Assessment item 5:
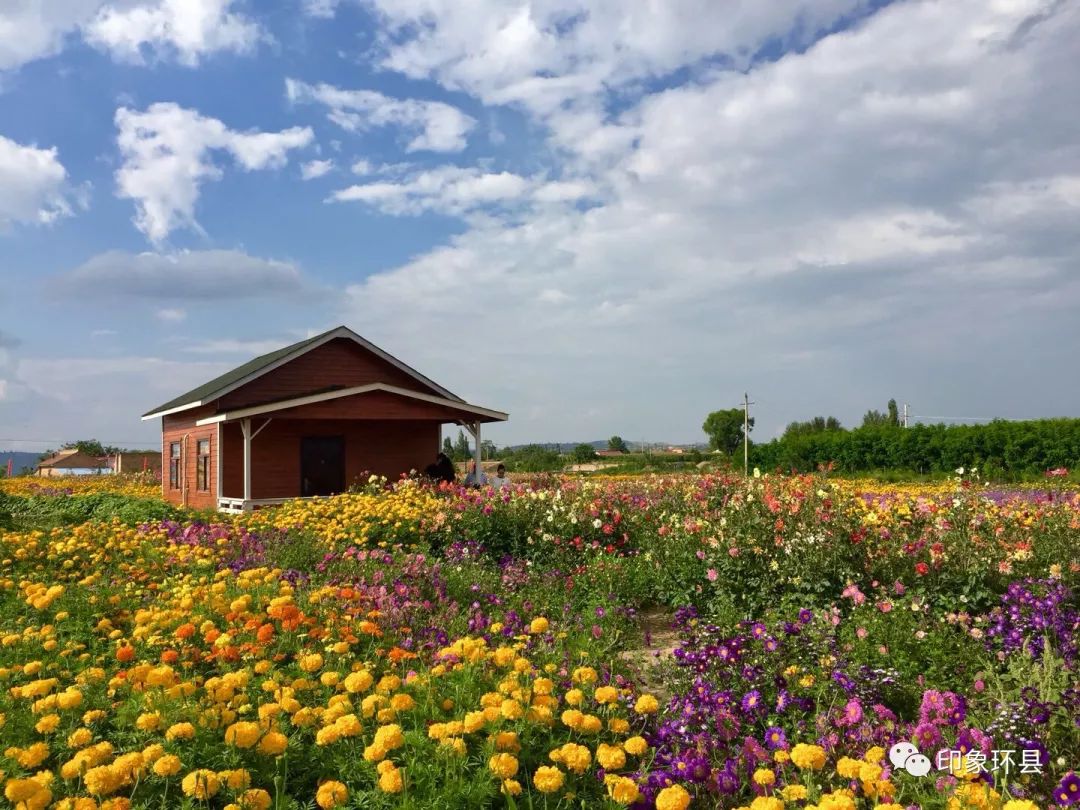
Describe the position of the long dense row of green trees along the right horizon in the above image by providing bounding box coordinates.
[751,419,1080,480]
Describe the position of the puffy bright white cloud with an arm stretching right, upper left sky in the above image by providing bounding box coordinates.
[116,104,312,243]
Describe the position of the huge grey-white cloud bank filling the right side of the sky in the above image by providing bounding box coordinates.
[334,0,1080,441]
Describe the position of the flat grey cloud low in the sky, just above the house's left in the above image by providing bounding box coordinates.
[51,251,318,301]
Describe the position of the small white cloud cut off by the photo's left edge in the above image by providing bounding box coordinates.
[0,135,78,232]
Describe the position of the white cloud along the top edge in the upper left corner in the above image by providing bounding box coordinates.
[0,0,266,70]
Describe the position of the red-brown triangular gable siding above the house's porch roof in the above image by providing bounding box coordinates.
[217,338,442,410]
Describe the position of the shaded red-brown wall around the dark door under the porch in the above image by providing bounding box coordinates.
[219,415,441,498]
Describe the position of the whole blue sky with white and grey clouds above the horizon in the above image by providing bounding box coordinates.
[0,0,1080,449]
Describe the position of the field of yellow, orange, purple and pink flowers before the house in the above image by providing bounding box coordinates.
[0,474,1080,810]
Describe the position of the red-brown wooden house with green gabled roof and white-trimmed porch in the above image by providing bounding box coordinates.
[143,326,508,511]
